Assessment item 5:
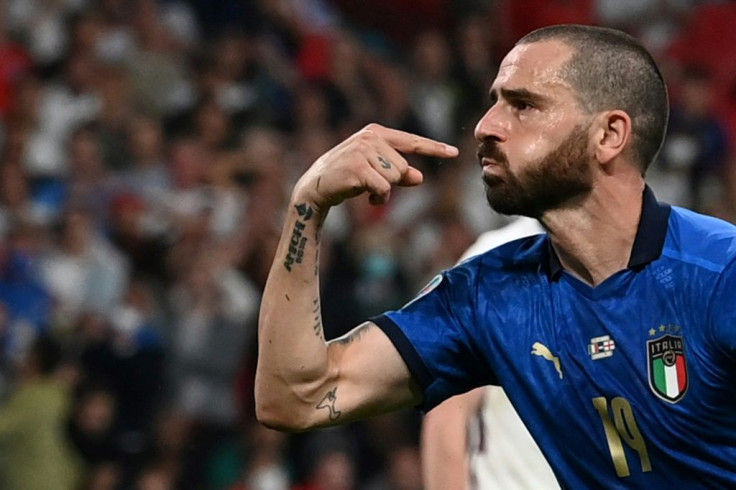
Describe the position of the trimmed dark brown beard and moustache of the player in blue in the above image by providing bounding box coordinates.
[478,126,593,218]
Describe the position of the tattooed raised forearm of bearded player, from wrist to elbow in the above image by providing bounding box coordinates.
[256,192,328,428]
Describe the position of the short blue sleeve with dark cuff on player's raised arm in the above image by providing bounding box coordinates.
[372,262,493,411]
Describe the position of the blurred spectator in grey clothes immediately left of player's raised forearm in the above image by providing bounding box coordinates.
[170,242,257,427]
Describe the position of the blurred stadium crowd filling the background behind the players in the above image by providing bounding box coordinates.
[0,0,736,490]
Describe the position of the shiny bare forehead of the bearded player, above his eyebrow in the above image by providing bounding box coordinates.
[491,41,573,92]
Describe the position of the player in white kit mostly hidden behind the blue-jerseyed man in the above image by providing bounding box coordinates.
[422,217,560,490]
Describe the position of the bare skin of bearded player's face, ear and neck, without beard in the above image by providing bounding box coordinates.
[475,41,644,286]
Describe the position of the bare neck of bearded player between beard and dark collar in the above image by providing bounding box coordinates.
[540,175,644,286]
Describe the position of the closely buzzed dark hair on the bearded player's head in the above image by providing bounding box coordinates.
[517,24,669,174]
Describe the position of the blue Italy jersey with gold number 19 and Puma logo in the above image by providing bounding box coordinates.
[373,189,736,489]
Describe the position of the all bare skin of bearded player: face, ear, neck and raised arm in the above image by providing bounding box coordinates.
[255,41,644,430]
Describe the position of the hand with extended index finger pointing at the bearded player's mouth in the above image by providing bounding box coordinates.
[293,124,458,211]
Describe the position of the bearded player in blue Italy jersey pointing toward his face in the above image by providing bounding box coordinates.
[256,25,736,488]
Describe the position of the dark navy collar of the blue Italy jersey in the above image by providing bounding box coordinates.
[547,186,672,280]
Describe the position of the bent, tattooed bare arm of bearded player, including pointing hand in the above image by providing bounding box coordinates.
[256,125,457,430]
